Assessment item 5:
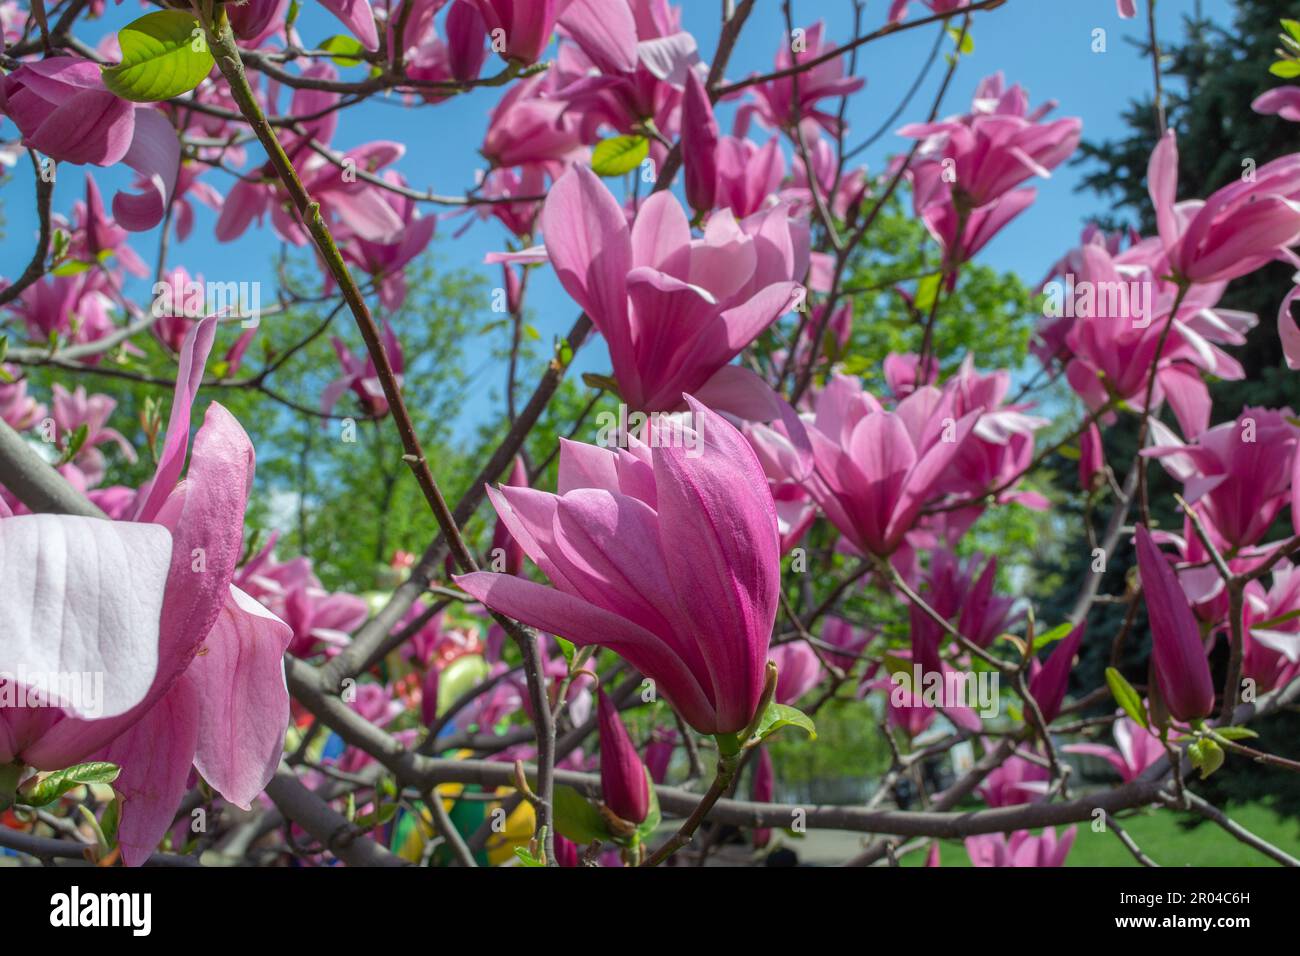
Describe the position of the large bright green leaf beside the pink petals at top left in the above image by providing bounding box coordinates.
[103,10,213,103]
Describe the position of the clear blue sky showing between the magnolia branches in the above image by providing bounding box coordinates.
[0,0,1231,437]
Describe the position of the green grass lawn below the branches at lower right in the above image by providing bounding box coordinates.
[902,804,1300,866]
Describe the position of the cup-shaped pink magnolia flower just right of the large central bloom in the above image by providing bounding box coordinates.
[807,373,979,555]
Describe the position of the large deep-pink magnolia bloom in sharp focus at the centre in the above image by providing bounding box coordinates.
[456,398,780,734]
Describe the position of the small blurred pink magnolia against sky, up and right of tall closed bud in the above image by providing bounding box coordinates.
[742,21,867,135]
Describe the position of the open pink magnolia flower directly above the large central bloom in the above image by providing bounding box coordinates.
[542,166,807,412]
